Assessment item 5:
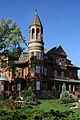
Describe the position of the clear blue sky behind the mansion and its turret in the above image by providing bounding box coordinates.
[0,0,80,75]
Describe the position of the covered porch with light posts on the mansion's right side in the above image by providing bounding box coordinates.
[45,79,80,92]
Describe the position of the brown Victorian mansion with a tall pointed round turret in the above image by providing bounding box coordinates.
[0,12,80,97]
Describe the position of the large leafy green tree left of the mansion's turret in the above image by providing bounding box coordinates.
[0,19,27,68]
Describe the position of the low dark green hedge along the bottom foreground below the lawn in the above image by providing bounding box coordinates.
[0,109,79,120]
